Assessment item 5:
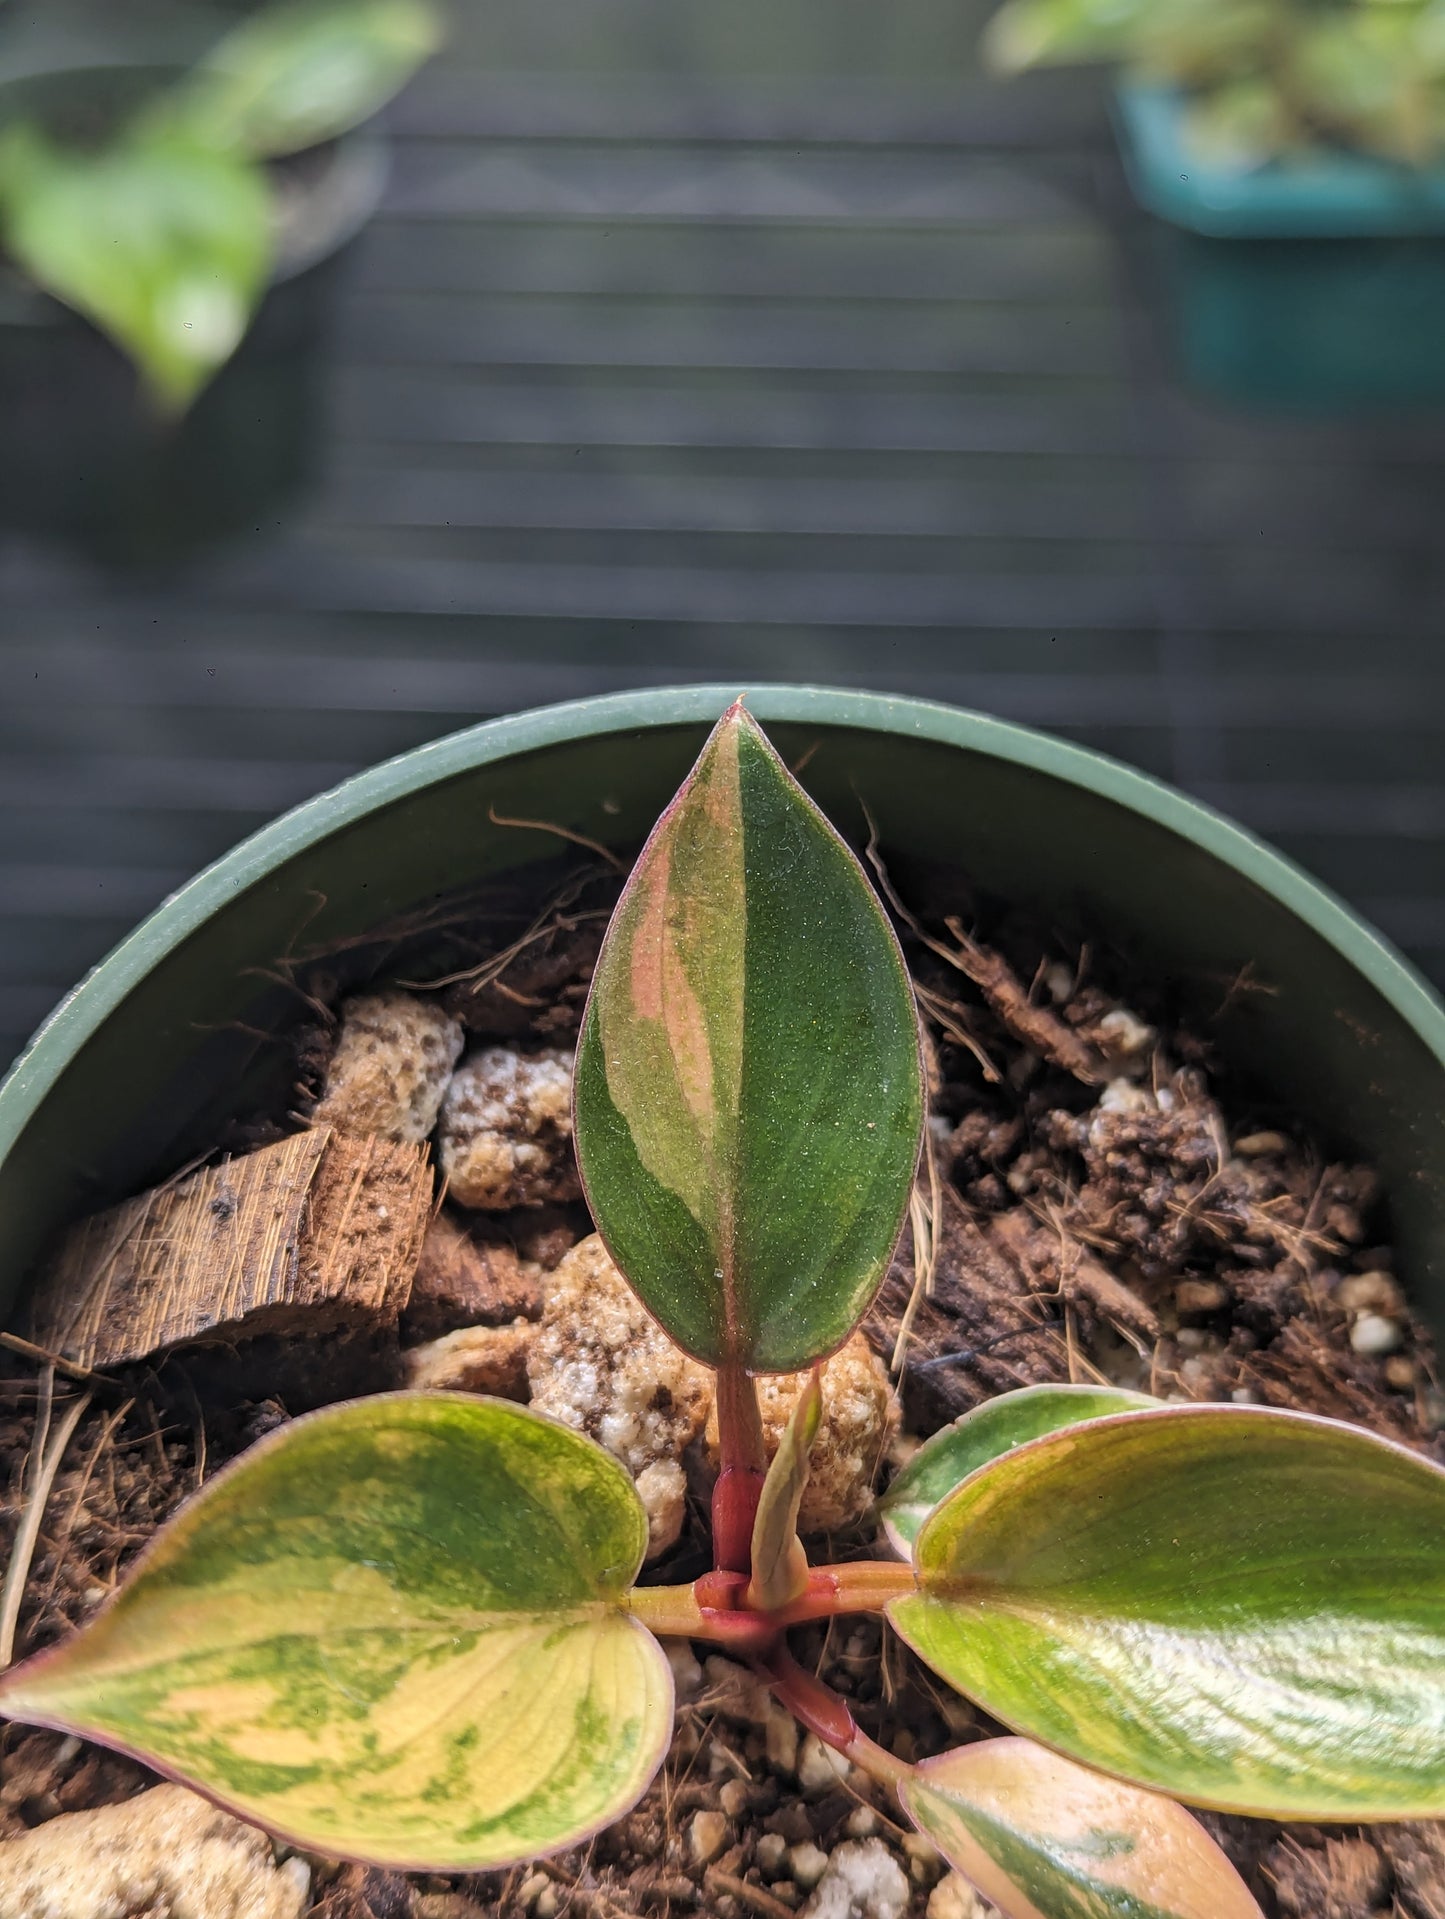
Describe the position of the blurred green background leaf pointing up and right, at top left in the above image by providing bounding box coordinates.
[155,0,441,157]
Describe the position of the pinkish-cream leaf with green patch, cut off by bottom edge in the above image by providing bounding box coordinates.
[898,1739,1261,1919]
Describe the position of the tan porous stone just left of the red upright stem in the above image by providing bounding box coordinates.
[528,1234,712,1558]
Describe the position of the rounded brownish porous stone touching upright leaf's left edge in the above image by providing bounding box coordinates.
[438,1046,581,1213]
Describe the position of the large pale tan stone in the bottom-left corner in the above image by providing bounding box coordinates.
[0,1787,311,1919]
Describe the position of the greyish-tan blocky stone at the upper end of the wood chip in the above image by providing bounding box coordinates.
[311,992,462,1146]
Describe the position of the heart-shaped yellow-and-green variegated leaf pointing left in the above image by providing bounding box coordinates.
[0,1393,672,1871]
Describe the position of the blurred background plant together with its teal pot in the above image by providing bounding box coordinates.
[984,0,1445,409]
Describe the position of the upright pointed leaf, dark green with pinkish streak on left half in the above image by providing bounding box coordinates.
[576,706,923,1372]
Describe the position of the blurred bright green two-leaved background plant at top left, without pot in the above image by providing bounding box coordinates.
[0,0,441,413]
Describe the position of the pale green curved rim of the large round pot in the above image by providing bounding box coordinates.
[0,681,1445,1161]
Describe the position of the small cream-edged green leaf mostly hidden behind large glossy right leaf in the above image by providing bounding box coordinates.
[879,1386,1159,1556]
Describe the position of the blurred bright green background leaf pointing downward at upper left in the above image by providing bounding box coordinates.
[0,125,272,411]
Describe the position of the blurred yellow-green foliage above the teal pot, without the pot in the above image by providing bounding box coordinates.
[984,0,1445,169]
